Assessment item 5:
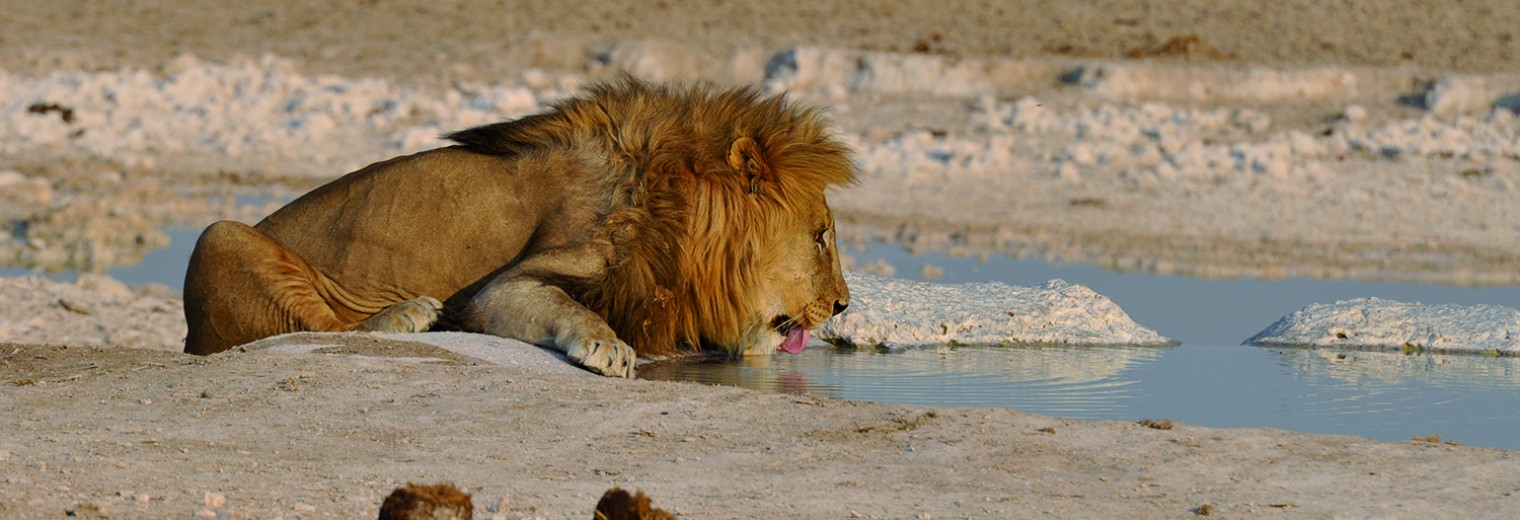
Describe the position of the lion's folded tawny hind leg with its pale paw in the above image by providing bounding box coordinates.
[184,220,442,354]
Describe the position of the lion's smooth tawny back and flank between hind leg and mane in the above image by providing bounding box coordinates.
[255,147,565,298]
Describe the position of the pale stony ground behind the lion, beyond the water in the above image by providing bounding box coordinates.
[0,2,1520,284]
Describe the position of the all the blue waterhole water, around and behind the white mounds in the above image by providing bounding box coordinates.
[0,230,1520,450]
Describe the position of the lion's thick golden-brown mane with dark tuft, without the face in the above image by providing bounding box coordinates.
[447,78,856,357]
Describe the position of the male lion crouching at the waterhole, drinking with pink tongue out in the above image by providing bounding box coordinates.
[184,79,854,377]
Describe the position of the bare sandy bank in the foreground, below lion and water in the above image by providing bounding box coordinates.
[0,341,1520,518]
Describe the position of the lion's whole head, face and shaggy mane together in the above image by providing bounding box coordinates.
[559,81,856,356]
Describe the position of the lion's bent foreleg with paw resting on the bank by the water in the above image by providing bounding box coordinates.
[465,275,637,377]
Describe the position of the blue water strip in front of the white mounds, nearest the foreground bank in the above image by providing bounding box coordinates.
[638,345,1520,450]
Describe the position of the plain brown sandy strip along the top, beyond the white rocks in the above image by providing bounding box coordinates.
[0,0,1520,79]
